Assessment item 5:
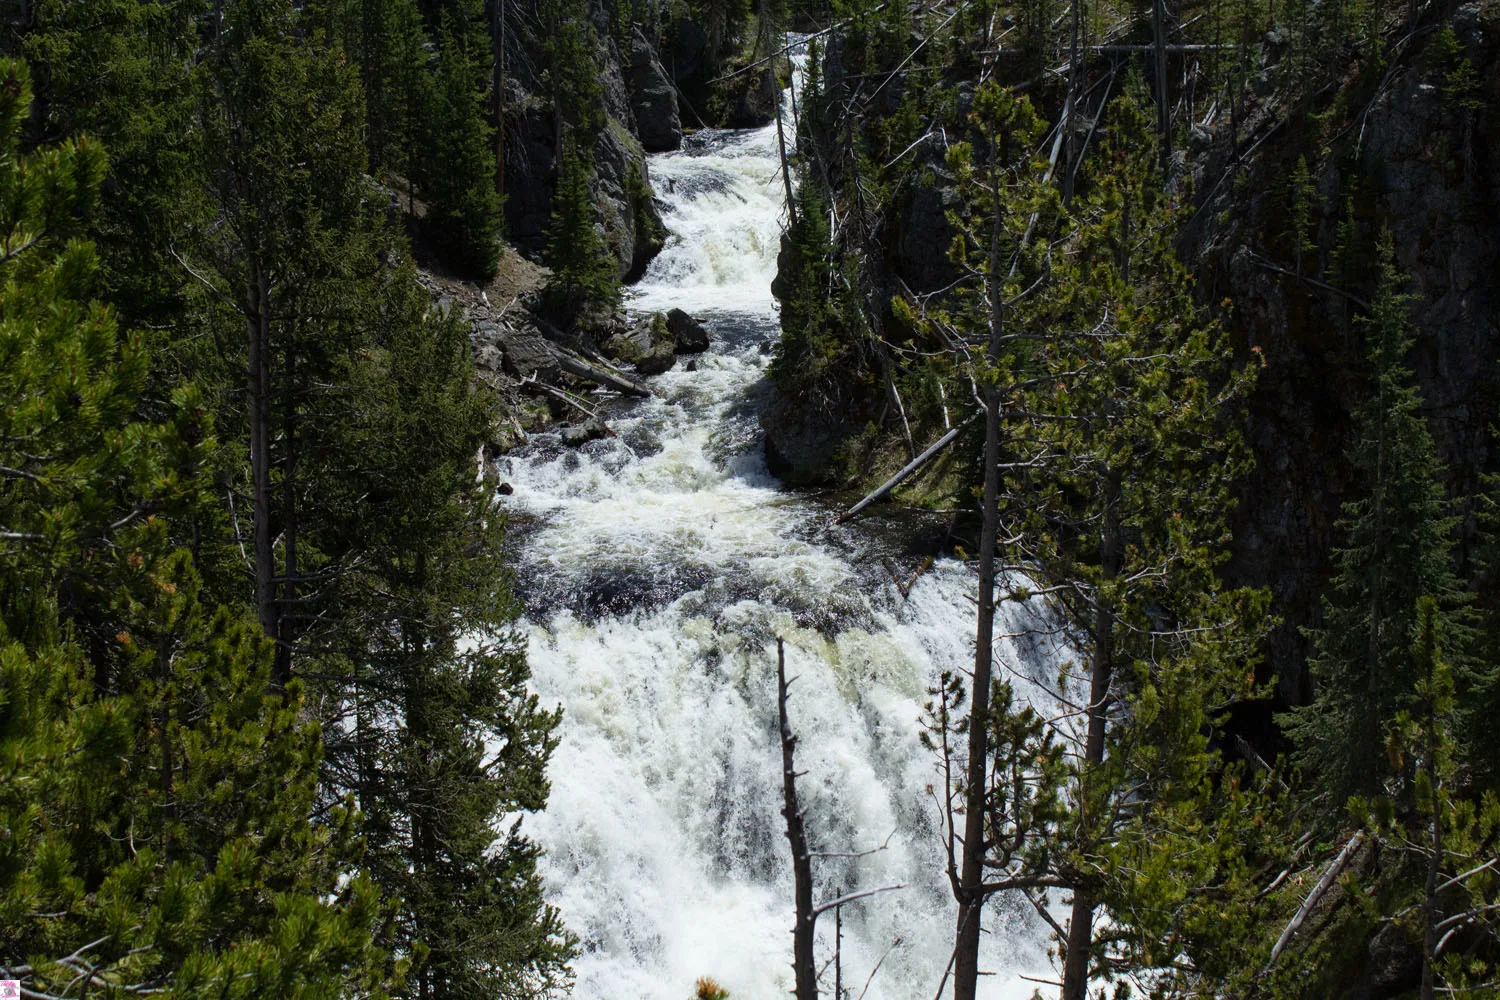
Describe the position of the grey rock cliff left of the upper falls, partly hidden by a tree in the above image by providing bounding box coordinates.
[506,0,683,279]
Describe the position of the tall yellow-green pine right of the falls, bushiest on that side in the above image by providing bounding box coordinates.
[1038,99,1268,999]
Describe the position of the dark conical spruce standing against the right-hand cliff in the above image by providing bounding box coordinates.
[1287,234,1460,801]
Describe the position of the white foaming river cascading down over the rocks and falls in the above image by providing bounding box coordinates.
[501,64,1049,1000]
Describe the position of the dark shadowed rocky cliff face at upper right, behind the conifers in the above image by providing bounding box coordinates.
[1182,3,1500,702]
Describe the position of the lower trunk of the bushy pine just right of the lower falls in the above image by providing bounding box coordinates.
[1061,475,1122,1000]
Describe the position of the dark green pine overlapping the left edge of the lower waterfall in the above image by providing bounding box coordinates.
[320,273,572,1000]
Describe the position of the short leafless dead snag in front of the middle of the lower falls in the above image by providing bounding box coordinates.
[776,639,906,1000]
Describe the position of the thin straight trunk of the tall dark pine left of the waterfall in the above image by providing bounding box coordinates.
[245,264,278,665]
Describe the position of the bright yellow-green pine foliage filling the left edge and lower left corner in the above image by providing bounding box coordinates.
[0,61,399,1000]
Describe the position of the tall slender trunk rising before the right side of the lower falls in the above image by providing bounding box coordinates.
[953,142,1005,1000]
